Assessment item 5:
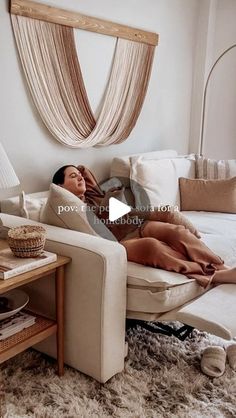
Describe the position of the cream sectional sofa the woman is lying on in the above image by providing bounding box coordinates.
[1,151,236,382]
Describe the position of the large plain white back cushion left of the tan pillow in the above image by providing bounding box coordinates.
[130,155,195,208]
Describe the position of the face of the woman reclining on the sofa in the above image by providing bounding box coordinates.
[61,166,86,197]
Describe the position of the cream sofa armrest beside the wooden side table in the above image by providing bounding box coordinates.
[1,214,127,382]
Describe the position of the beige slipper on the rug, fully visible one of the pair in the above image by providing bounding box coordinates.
[201,346,226,377]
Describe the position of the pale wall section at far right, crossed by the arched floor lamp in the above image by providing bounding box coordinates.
[204,0,236,158]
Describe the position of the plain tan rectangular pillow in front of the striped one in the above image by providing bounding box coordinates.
[179,177,236,213]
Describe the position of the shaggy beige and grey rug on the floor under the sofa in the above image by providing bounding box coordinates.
[0,327,236,418]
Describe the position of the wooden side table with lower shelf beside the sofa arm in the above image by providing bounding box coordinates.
[0,240,71,376]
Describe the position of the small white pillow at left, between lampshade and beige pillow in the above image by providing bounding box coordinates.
[19,191,47,222]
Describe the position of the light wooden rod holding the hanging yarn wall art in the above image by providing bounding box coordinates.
[11,0,158,46]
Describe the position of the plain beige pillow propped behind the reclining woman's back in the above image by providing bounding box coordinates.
[40,184,97,235]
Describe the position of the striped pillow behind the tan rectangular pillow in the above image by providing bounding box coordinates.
[196,156,236,180]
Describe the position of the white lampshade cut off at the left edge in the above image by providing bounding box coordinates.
[0,143,20,189]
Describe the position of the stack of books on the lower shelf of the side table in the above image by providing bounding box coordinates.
[0,312,36,341]
